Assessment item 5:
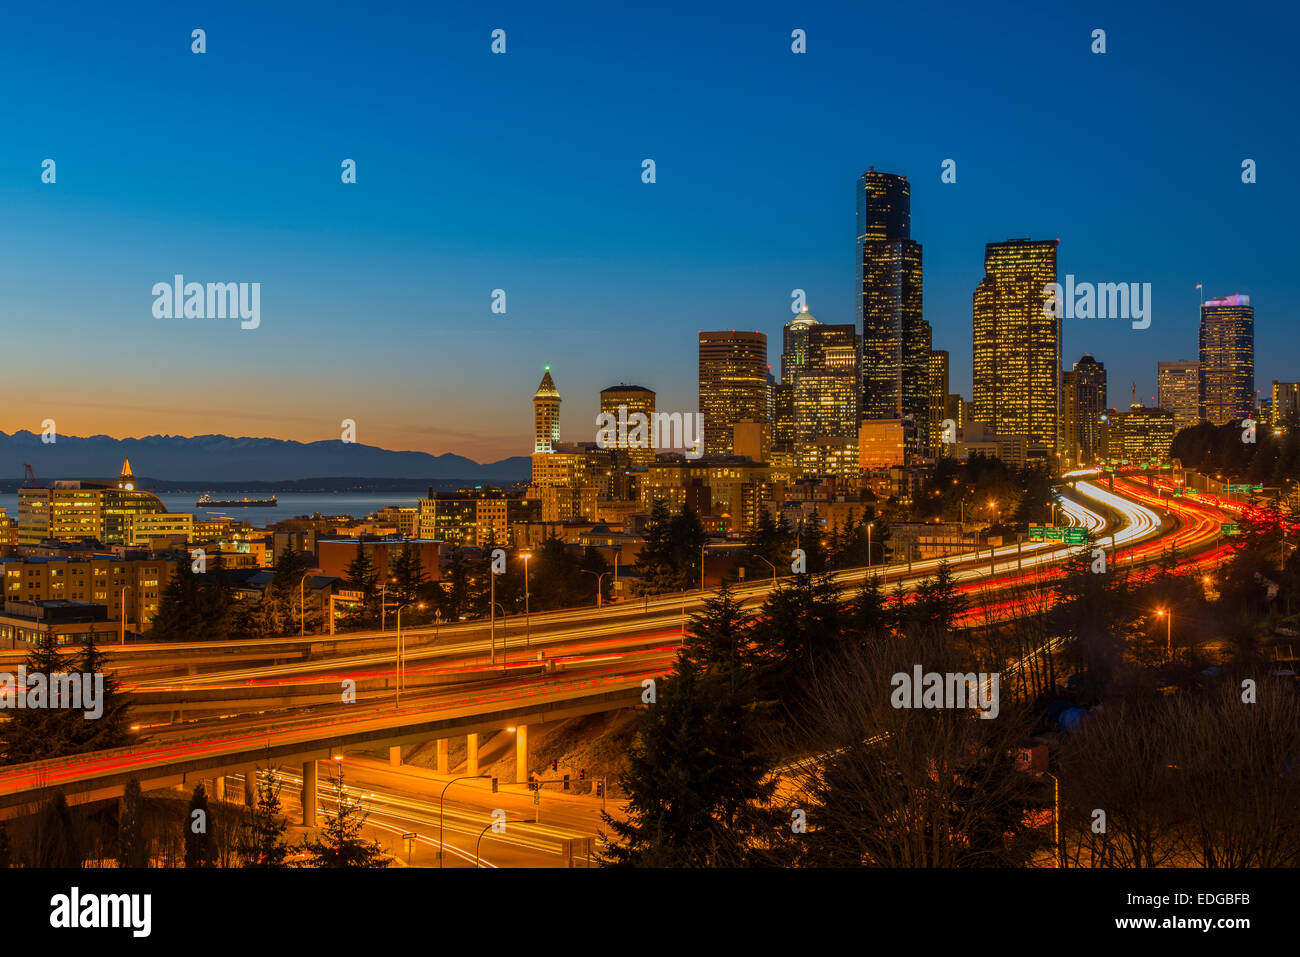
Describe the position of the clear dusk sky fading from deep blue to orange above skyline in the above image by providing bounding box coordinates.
[0,1,1300,462]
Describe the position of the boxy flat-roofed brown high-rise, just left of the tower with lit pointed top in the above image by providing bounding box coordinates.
[699,330,767,455]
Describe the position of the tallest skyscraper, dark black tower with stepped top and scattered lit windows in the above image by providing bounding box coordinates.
[857,168,930,456]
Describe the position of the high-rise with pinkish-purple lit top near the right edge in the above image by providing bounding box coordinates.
[1200,294,1255,425]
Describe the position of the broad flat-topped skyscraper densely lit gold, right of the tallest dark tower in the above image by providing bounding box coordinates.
[972,239,1061,459]
